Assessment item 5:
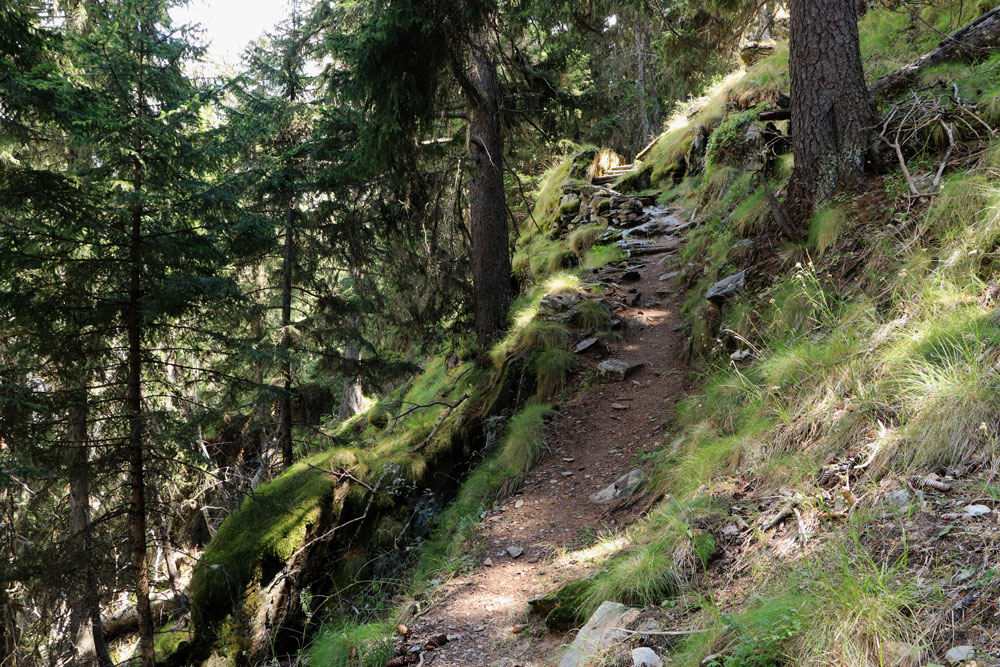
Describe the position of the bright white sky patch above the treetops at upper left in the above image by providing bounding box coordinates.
[170,0,289,66]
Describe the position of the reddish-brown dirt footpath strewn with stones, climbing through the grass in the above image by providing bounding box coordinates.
[407,211,690,667]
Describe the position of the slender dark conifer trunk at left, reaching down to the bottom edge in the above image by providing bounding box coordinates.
[125,70,156,667]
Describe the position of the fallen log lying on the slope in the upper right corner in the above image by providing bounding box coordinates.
[872,7,1000,99]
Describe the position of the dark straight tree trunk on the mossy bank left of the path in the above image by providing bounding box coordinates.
[469,30,510,364]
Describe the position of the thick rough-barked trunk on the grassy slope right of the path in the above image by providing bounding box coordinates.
[786,0,878,222]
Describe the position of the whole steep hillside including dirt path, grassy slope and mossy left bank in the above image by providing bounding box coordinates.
[175,3,1000,667]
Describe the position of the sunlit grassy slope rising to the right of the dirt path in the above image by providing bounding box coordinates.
[553,3,1000,667]
